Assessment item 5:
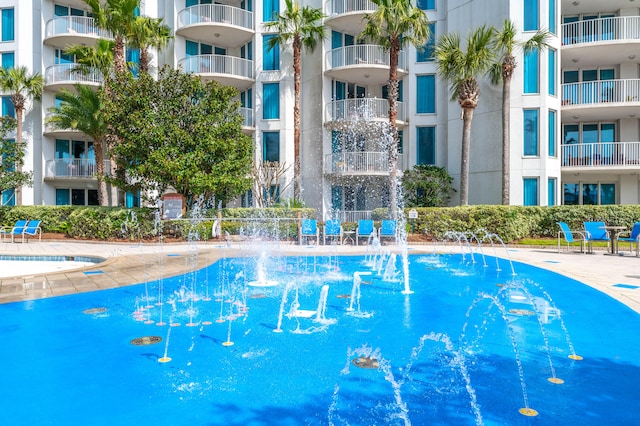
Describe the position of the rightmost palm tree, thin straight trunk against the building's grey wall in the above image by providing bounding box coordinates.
[490,19,550,205]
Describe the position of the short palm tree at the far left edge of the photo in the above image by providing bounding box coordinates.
[0,66,44,205]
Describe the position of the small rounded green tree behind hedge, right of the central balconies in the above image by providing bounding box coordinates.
[402,164,455,207]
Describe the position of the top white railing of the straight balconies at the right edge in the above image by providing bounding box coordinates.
[562,16,640,45]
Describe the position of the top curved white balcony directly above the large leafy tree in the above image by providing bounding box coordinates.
[176,4,255,47]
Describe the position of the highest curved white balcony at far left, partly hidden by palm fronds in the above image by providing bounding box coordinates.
[44,16,113,49]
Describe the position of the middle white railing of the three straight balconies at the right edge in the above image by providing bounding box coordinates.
[562,79,640,105]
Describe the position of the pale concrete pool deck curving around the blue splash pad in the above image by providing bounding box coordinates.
[0,240,640,313]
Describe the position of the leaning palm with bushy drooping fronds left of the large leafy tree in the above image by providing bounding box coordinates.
[46,84,109,206]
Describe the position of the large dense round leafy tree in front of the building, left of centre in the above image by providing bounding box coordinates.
[103,67,252,206]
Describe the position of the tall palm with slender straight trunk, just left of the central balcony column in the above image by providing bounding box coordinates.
[264,0,325,200]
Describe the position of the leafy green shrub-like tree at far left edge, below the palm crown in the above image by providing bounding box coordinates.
[0,115,33,204]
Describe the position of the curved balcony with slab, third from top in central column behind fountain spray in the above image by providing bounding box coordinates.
[325,98,407,130]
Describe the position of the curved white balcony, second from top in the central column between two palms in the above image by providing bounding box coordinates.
[325,44,407,85]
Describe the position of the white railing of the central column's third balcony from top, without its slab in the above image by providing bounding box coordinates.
[327,98,407,121]
